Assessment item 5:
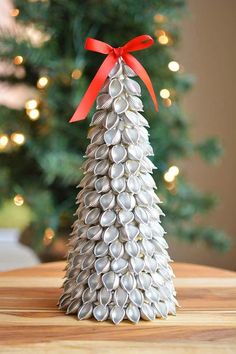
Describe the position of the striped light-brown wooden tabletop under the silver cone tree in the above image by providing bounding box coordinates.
[0,262,236,354]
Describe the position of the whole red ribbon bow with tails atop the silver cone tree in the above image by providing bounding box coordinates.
[70,34,158,123]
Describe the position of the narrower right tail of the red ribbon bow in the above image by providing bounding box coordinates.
[123,53,158,111]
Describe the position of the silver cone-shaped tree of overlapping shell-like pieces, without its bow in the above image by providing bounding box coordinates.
[59,54,177,324]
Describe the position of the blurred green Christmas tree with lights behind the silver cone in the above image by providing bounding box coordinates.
[0,0,228,252]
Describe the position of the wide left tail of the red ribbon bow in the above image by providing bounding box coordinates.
[70,53,117,123]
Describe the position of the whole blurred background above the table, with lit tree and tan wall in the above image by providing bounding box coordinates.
[0,0,236,270]
